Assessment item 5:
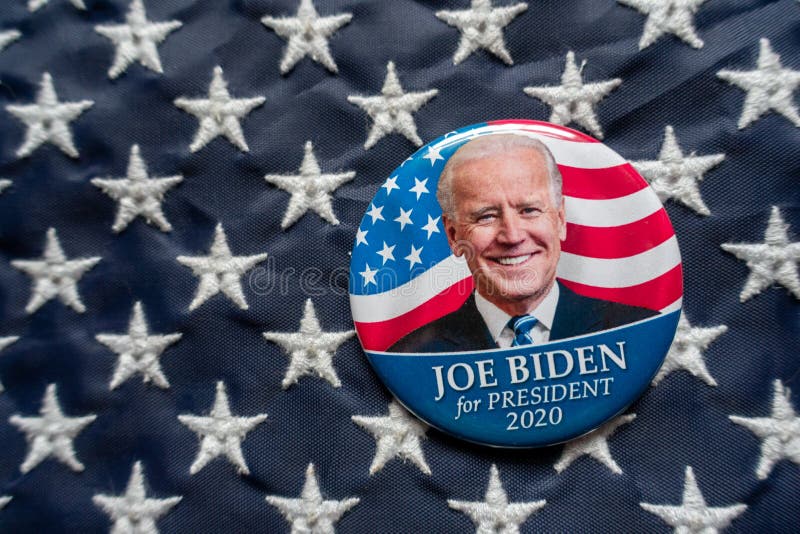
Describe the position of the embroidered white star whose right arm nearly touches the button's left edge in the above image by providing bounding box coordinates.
[264,299,355,389]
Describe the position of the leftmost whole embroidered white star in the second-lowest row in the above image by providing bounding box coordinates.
[8,384,97,473]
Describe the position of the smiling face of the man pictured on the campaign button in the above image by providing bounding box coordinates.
[442,147,567,315]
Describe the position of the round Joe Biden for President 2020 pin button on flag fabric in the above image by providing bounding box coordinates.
[350,120,683,447]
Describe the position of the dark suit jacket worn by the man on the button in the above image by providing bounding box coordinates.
[387,284,658,352]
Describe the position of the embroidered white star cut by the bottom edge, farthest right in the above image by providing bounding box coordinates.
[639,466,747,534]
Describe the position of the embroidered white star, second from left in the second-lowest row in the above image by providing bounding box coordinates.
[178,381,267,475]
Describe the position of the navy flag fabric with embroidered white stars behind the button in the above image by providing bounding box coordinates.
[0,0,800,533]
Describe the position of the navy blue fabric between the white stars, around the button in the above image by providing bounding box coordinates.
[0,0,800,532]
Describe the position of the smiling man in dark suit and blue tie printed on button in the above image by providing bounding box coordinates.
[388,134,657,352]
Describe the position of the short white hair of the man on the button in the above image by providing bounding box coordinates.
[436,134,562,218]
